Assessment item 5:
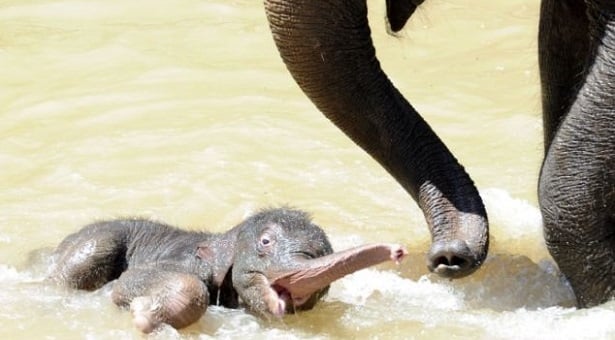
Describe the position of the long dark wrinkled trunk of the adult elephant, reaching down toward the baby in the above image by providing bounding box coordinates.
[265,0,489,277]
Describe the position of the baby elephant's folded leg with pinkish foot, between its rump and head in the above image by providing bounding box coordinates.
[111,267,209,333]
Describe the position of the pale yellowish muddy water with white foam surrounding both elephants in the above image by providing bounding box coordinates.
[0,0,615,339]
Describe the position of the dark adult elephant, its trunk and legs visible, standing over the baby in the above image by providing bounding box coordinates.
[265,0,615,306]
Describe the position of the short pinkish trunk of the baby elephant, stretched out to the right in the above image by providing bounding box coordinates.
[272,244,408,297]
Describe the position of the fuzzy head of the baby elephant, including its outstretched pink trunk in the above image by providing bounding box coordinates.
[224,209,407,317]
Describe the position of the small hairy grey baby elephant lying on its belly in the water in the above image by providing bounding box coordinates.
[49,208,407,333]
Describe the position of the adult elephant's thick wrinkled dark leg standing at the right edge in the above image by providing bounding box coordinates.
[539,0,615,307]
